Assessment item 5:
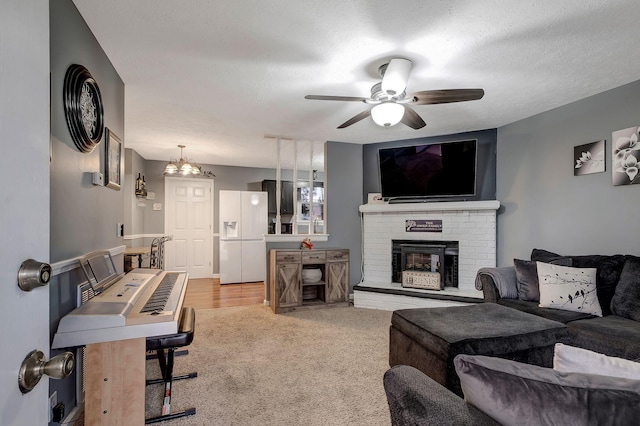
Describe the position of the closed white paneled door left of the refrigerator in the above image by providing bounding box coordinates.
[165,178,213,278]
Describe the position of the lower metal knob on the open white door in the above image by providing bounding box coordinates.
[18,350,75,393]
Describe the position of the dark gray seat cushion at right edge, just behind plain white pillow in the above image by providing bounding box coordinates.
[567,315,640,361]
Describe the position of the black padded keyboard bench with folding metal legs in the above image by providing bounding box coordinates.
[145,306,198,424]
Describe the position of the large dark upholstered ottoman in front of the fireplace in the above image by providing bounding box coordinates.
[389,303,567,396]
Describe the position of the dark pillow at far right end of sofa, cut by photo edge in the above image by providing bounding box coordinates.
[611,256,640,321]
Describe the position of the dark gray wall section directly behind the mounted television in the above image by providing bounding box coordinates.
[362,129,496,203]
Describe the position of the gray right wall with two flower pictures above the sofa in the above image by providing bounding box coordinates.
[497,81,640,266]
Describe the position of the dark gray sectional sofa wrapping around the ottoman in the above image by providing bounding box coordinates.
[384,249,640,426]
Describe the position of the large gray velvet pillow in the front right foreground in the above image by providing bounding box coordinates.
[453,355,640,425]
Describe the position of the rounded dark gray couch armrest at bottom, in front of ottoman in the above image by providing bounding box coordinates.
[384,365,498,426]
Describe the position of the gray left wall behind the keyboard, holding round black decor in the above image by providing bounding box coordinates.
[49,0,126,420]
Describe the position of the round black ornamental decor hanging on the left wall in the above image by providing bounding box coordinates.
[63,64,104,152]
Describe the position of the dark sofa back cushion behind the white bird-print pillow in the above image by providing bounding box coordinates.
[531,248,625,315]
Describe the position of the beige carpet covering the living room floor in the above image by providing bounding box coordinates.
[146,305,391,426]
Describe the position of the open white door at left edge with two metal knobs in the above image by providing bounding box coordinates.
[0,0,49,425]
